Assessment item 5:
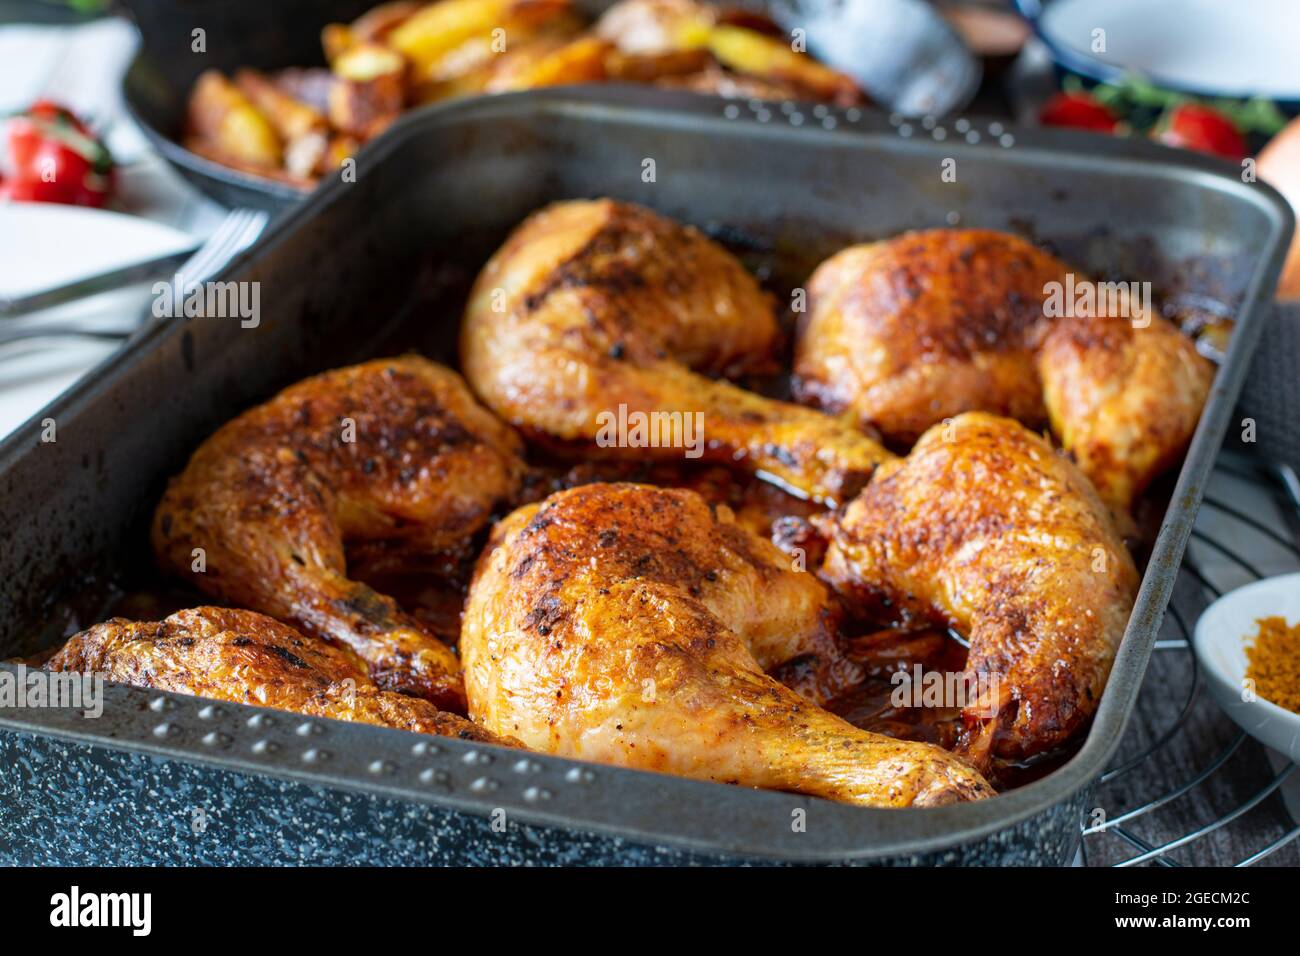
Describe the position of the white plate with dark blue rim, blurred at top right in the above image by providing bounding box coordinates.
[1040,0,1300,100]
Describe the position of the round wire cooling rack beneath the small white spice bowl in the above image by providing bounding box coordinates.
[1079,451,1300,866]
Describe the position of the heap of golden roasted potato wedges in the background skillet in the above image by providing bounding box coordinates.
[175,0,863,183]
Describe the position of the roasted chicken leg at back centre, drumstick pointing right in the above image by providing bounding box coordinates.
[460,199,891,501]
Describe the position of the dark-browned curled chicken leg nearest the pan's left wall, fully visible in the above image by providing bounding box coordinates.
[153,356,524,711]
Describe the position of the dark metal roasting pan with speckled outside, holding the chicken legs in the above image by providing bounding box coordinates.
[0,87,1292,864]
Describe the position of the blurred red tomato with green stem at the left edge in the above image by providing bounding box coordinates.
[4,100,113,207]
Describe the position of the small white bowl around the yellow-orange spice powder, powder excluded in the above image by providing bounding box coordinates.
[1192,574,1300,763]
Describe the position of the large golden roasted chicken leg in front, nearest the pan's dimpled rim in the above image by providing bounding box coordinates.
[460,484,992,806]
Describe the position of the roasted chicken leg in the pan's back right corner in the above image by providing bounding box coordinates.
[794,229,1213,514]
